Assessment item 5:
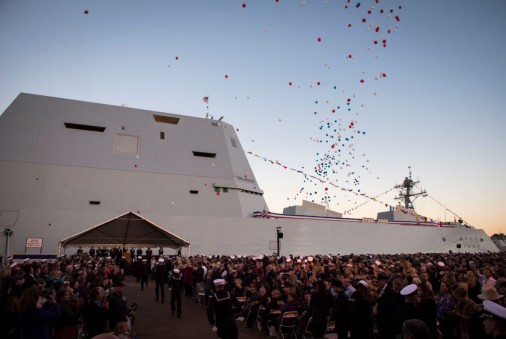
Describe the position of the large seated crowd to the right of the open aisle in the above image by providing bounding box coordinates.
[191,253,506,338]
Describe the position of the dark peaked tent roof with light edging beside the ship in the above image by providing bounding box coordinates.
[60,212,190,249]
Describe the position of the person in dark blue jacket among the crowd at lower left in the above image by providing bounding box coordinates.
[19,286,60,339]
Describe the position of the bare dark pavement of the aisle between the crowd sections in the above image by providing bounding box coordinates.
[123,276,267,339]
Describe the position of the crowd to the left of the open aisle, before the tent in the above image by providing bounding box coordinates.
[0,253,131,339]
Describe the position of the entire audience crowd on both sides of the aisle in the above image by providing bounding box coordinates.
[0,248,506,339]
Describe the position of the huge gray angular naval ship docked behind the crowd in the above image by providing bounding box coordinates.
[0,93,498,255]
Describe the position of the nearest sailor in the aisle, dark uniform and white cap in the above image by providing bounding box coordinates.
[207,279,238,339]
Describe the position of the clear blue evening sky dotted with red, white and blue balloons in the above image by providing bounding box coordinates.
[0,0,506,235]
